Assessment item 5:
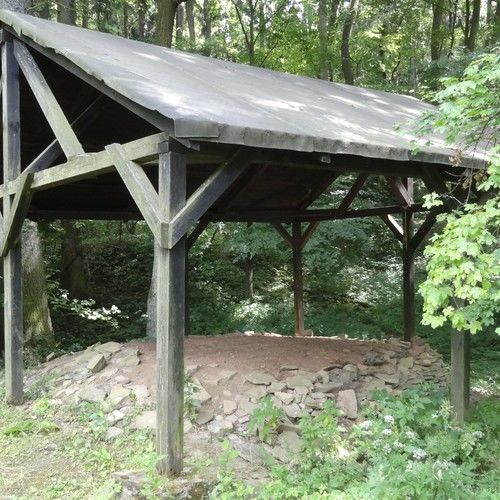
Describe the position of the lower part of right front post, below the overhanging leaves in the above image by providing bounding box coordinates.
[450,332,470,424]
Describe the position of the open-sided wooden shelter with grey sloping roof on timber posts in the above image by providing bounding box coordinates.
[0,11,476,473]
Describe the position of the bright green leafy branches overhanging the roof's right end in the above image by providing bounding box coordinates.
[412,49,500,334]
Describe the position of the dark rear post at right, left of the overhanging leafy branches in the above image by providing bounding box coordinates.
[403,178,415,342]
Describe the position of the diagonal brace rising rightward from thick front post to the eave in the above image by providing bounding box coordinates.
[167,148,255,248]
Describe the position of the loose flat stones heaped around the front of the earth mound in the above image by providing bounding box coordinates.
[37,338,446,460]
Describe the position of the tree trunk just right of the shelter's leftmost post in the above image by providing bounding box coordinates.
[22,220,54,346]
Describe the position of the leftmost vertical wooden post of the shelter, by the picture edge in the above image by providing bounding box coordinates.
[2,37,23,404]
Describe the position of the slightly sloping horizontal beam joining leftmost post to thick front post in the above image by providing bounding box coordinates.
[0,132,168,197]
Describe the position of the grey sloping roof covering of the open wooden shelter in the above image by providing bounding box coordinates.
[0,10,480,164]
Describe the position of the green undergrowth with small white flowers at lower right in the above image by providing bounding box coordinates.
[215,385,500,500]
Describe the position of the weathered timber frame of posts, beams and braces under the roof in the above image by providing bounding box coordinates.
[0,30,468,473]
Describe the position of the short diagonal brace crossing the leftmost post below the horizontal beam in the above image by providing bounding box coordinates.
[2,171,34,257]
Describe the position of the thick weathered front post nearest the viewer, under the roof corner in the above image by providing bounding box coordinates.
[155,143,186,475]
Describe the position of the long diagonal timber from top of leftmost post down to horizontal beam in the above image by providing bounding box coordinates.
[14,40,85,158]
